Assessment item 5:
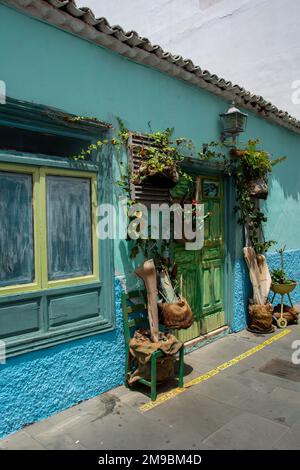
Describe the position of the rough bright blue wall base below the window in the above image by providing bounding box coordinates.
[0,279,125,438]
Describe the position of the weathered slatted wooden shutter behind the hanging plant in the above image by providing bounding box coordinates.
[128,134,170,207]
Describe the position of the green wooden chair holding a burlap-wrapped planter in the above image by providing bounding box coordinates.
[122,291,184,401]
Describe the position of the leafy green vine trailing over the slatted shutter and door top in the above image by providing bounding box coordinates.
[73,118,286,256]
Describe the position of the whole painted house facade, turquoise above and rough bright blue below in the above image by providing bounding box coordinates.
[0,5,300,436]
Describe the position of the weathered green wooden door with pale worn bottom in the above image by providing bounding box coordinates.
[173,176,225,341]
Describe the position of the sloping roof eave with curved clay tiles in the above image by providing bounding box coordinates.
[1,0,300,134]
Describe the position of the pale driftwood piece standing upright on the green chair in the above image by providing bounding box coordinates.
[135,259,159,343]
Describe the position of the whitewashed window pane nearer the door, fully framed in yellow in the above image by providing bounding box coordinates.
[47,176,93,280]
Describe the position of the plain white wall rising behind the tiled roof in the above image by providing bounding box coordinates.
[77,0,300,119]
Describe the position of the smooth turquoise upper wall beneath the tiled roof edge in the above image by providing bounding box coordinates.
[0,5,300,260]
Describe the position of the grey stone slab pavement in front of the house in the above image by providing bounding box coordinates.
[0,325,300,450]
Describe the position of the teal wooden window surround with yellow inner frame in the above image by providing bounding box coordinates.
[0,97,116,357]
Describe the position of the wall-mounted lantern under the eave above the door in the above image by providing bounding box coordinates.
[220,101,248,147]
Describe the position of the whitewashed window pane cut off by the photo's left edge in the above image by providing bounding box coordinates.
[0,171,34,287]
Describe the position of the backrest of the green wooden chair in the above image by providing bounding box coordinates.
[122,290,149,347]
